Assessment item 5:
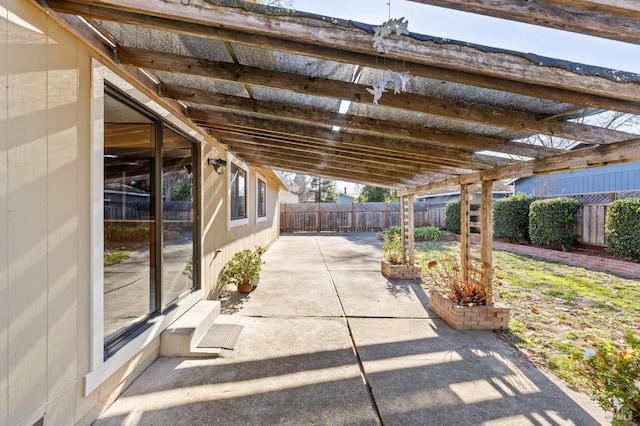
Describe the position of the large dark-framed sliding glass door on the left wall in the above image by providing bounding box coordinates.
[103,86,198,359]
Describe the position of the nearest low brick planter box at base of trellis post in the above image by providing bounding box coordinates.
[429,290,511,330]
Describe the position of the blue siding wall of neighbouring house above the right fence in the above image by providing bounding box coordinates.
[515,163,640,196]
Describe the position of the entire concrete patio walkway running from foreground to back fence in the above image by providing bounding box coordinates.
[96,234,608,426]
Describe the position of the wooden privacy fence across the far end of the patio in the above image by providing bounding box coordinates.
[280,202,444,232]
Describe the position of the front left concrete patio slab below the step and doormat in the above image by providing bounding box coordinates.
[95,318,377,426]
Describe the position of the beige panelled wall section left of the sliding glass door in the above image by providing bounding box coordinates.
[0,0,90,425]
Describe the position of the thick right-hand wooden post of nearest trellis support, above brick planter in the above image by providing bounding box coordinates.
[480,180,493,305]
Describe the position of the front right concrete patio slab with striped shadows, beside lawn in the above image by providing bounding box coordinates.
[349,318,605,426]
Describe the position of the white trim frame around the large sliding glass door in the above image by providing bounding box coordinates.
[83,59,204,397]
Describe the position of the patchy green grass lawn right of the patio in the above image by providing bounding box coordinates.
[416,241,640,391]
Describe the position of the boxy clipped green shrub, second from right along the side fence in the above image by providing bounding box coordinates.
[529,197,580,250]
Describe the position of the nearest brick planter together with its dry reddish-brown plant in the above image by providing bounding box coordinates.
[427,257,510,330]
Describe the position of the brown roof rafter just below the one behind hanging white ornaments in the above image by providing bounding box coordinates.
[160,84,563,158]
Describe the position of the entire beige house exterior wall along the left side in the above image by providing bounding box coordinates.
[0,0,279,426]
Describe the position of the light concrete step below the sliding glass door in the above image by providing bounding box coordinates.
[160,300,221,357]
